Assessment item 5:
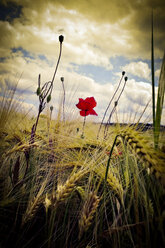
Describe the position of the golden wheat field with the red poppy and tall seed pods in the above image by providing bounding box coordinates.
[0,34,165,248]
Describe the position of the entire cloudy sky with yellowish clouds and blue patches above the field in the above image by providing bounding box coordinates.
[0,0,165,124]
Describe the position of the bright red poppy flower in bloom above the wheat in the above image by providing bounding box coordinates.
[76,97,97,116]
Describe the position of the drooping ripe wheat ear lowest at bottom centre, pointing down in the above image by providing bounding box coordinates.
[79,192,100,239]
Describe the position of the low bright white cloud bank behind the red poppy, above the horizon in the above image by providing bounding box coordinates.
[1,46,164,123]
